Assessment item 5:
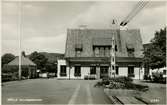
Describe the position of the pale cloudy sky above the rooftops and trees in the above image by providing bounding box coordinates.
[1,1,167,55]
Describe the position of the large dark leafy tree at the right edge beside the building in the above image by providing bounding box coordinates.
[144,28,166,69]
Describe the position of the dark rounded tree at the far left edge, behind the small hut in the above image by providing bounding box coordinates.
[1,53,15,67]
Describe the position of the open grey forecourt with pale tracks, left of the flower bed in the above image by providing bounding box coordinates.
[2,78,111,104]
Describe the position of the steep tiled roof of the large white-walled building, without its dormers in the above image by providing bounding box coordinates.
[65,29,143,58]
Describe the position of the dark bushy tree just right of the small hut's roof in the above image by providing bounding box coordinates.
[29,51,48,70]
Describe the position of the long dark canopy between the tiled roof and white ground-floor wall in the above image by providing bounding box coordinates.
[66,57,142,67]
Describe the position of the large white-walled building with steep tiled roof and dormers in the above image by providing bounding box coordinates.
[57,29,144,79]
